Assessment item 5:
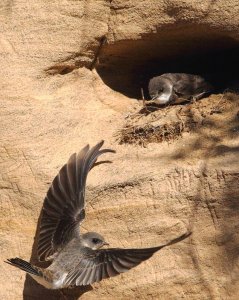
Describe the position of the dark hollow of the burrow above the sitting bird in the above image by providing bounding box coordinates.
[96,24,239,99]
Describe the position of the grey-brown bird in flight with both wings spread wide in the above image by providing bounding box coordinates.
[6,141,190,289]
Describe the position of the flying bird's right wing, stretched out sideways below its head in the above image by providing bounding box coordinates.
[64,233,191,286]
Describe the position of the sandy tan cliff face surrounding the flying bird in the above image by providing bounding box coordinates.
[0,0,239,300]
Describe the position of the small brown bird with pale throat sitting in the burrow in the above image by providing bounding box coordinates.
[148,73,214,104]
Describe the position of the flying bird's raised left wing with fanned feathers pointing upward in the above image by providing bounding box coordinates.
[38,141,115,261]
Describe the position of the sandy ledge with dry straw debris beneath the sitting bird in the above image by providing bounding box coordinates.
[116,93,239,146]
